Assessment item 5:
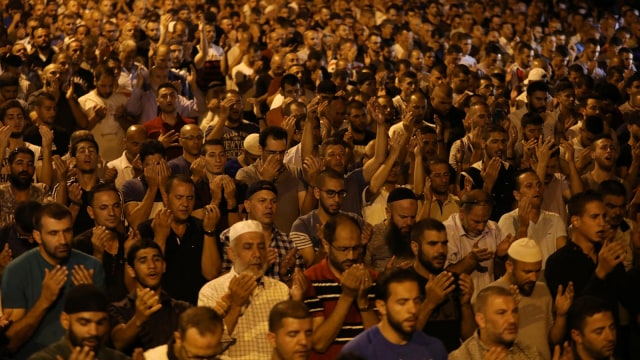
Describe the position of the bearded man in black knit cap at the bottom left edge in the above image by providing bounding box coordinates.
[29,284,129,360]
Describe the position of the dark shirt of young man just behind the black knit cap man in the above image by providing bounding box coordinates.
[109,290,193,350]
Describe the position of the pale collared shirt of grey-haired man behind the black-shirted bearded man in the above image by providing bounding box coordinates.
[444,213,502,291]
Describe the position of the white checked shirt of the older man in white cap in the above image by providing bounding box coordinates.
[198,268,289,360]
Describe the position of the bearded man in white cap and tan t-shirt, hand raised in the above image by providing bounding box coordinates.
[490,238,574,360]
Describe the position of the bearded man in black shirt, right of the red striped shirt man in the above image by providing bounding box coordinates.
[411,218,476,351]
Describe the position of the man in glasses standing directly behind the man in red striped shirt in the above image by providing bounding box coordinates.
[289,169,364,267]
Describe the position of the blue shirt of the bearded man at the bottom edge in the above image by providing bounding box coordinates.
[340,325,447,360]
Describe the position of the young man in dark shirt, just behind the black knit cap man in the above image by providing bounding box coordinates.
[109,239,192,353]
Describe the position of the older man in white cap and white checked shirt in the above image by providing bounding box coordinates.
[198,220,289,360]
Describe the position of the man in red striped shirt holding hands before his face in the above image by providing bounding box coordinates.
[304,214,378,359]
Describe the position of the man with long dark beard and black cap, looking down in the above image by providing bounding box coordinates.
[364,187,418,272]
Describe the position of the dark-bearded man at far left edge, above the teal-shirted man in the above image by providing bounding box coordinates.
[0,147,47,226]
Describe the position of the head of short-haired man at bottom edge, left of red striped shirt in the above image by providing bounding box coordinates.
[267,300,313,360]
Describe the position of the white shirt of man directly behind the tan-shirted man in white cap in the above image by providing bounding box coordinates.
[498,209,567,269]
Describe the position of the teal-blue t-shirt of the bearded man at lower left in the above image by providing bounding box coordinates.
[2,248,105,359]
